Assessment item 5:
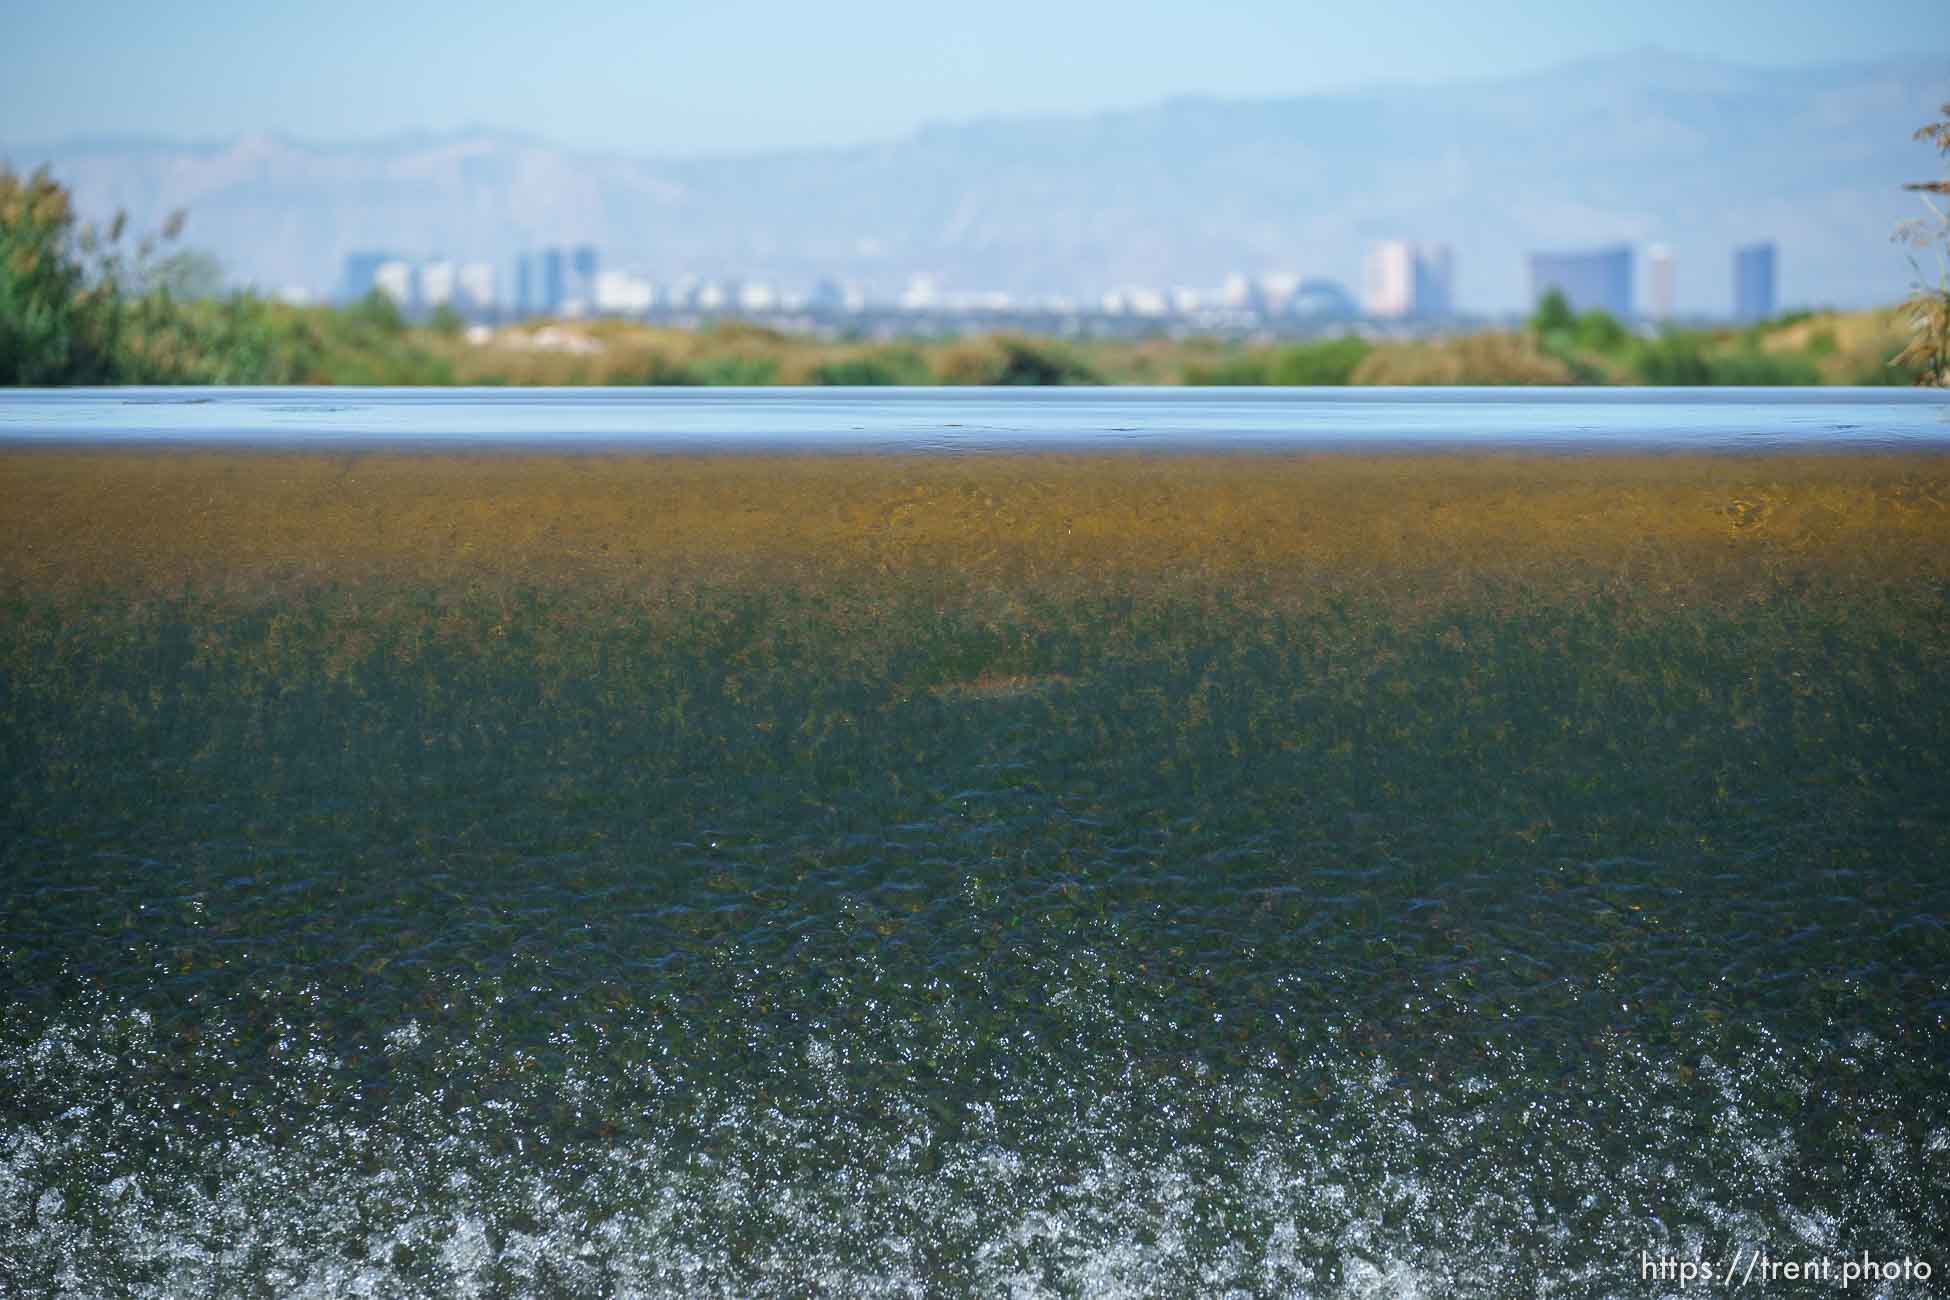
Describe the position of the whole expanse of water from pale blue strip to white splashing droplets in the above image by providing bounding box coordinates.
[0,390,1950,1296]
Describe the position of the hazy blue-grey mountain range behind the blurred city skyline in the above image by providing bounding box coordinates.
[0,51,1950,314]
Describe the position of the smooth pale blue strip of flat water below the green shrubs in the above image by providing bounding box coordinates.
[0,388,1950,452]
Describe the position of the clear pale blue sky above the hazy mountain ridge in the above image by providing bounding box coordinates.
[15,0,1950,154]
